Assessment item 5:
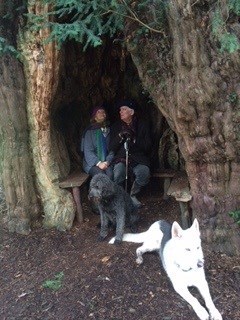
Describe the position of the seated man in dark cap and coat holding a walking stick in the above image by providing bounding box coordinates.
[109,100,151,206]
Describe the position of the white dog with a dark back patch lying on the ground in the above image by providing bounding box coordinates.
[109,219,222,320]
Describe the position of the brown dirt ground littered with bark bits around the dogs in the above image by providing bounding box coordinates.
[0,182,240,320]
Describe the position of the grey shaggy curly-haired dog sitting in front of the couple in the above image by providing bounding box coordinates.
[88,173,138,244]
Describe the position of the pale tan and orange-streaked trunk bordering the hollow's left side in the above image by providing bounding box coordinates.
[21,2,76,230]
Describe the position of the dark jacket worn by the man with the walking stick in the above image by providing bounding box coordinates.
[109,119,152,167]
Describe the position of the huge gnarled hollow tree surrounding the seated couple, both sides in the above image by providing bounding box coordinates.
[0,0,240,254]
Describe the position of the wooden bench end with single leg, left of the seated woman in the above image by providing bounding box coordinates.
[59,171,89,223]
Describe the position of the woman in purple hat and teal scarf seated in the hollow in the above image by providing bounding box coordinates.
[81,106,113,179]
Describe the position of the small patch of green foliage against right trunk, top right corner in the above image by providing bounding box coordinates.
[212,0,240,53]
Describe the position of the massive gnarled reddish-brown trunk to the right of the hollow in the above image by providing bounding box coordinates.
[129,0,240,254]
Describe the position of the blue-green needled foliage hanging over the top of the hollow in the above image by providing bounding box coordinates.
[28,0,126,49]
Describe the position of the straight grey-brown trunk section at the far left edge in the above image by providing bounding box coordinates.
[0,3,40,234]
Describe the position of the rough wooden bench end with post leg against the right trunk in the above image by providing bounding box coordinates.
[167,172,192,229]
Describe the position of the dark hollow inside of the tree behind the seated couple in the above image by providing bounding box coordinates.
[52,39,181,170]
